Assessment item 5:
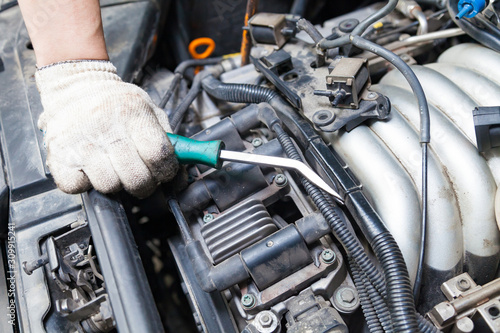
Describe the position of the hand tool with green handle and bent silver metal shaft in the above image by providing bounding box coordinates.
[167,133,344,204]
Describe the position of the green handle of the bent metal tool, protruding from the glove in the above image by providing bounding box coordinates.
[167,133,224,169]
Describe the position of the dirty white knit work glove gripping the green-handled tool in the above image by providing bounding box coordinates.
[35,60,178,197]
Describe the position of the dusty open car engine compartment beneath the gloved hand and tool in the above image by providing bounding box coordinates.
[0,0,500,333]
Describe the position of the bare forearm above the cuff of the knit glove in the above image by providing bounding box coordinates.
[19,0,108,66]
